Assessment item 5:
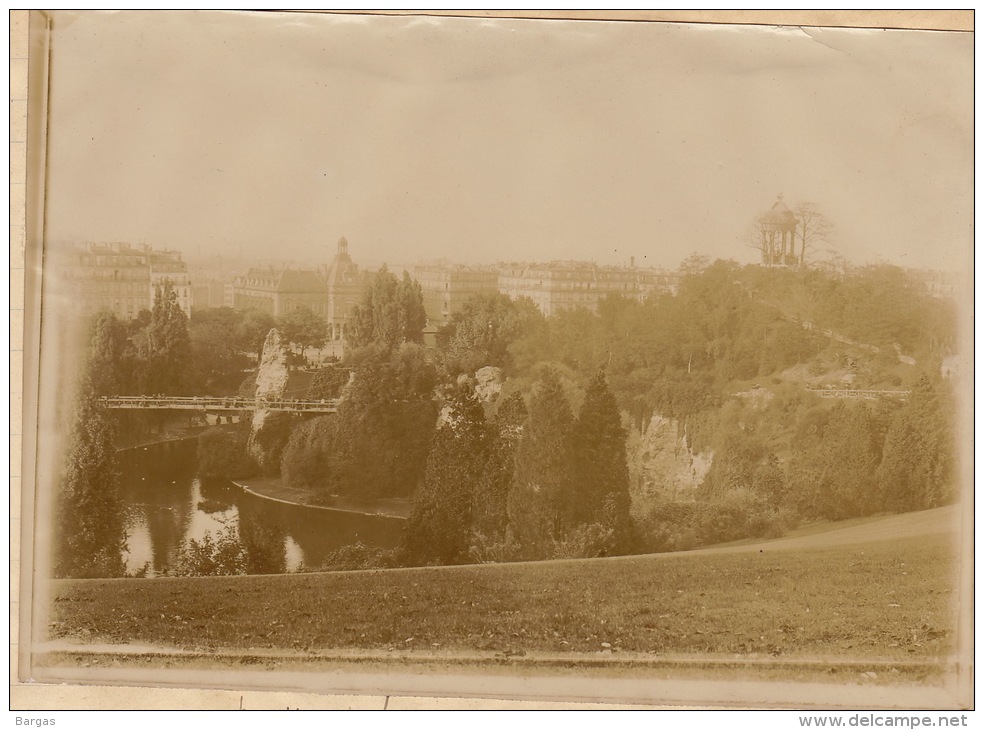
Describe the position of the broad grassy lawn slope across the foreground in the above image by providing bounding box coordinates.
[51,535,956,660]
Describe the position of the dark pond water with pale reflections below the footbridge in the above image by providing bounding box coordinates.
[118,439,404,577]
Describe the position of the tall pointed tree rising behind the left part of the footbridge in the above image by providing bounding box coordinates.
[138,279,191,395]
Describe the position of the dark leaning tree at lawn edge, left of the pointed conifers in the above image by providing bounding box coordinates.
[406,383,489,565]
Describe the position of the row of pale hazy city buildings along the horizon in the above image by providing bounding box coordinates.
[55,237,955,352]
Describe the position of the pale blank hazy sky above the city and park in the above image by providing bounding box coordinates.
[40,12,973,269]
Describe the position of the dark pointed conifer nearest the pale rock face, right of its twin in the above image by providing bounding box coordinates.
[573,370,631,550]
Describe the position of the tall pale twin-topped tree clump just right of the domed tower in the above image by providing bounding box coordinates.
[348,266,427,348]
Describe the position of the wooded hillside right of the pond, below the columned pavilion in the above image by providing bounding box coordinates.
[404,257,956,559]
